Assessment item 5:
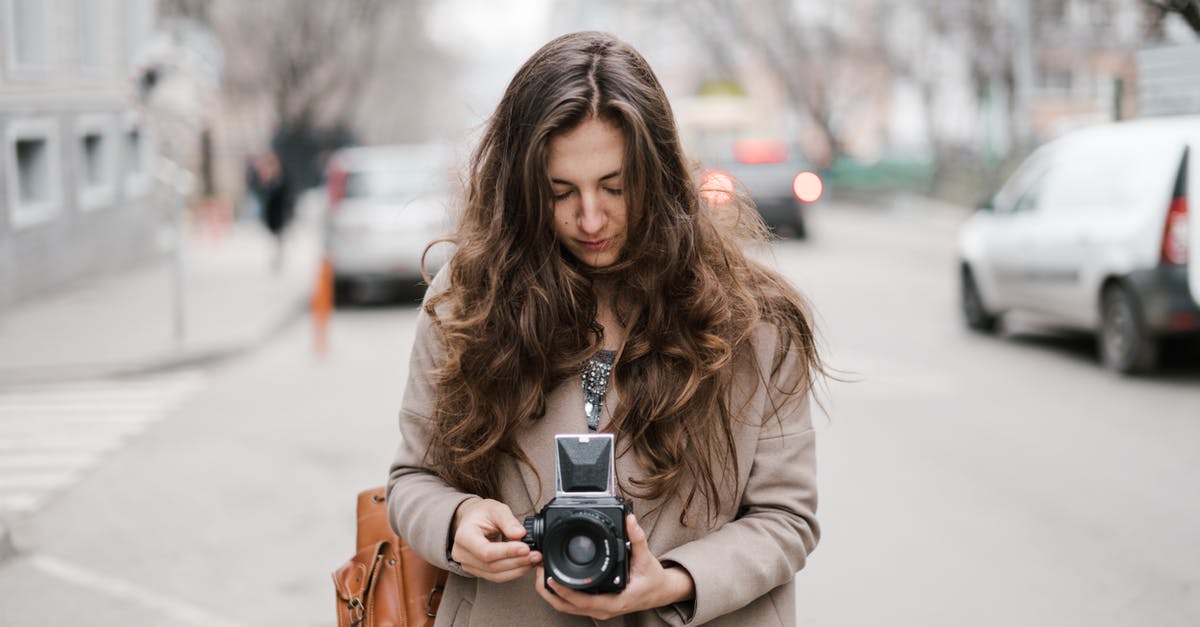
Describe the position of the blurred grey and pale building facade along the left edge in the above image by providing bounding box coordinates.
[0,0,162,314]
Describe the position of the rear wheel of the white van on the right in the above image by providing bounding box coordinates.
[1099,285,1158,374]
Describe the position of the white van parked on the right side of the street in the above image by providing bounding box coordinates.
[959,117,1200,372]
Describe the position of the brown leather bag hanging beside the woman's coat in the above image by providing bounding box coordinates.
[334,488,446,627]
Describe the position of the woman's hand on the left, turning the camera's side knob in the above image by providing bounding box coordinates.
[450,497,541,584]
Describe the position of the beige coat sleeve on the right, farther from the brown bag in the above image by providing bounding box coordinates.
[658,329,820,626]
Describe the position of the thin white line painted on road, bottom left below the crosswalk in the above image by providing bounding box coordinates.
[29,555,247,627]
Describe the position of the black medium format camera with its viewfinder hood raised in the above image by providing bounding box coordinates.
[524,434,632,595]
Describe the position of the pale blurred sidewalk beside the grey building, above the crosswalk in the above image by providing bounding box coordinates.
[0,213,320,390]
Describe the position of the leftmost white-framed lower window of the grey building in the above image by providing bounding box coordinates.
[4,119,61,228]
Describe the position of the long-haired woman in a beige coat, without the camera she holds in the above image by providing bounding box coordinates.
[388,32,823,626]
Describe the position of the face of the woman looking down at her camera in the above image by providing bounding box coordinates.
[547,118,625,268]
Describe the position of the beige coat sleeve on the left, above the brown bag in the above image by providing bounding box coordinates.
[388,273,470,574]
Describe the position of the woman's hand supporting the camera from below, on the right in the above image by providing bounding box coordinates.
[535,514,695,621]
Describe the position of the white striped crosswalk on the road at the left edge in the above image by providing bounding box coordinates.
[0,371,205,514]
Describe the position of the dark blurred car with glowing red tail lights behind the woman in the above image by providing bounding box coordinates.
[707,139,824,239]
